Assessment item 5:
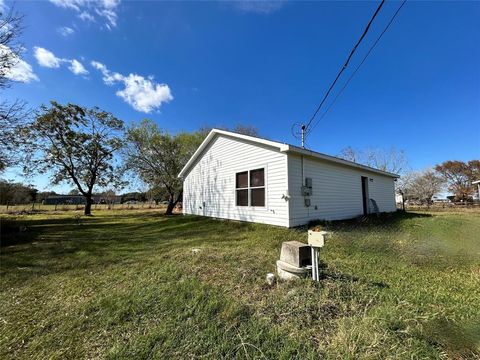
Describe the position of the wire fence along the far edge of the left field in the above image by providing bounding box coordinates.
[0,202,167,214]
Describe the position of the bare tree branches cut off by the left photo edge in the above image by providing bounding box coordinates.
[0,8,29,172]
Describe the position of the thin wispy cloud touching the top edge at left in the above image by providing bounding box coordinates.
[49,0,120,29]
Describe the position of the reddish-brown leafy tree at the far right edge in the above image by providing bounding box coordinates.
[435,160,480,201]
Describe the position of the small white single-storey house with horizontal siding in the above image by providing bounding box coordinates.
[179,129,398,227]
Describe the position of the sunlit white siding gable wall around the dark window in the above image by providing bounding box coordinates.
[183,135,288,226]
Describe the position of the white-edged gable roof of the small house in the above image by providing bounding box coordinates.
[178,129,400,178]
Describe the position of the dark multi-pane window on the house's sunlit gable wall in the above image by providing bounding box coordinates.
[235,169,265,206]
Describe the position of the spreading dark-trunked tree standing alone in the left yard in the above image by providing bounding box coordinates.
[25,101,124,215]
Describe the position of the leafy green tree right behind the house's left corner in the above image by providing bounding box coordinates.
[124,120,203,215]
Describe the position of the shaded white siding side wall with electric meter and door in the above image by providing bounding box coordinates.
[288,155,396,226]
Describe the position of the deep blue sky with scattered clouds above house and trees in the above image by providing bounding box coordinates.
[0,0,480,194]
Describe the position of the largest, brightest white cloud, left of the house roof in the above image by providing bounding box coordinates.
[91,61,173,113]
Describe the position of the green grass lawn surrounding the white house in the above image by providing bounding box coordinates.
[0,210,480,359]
